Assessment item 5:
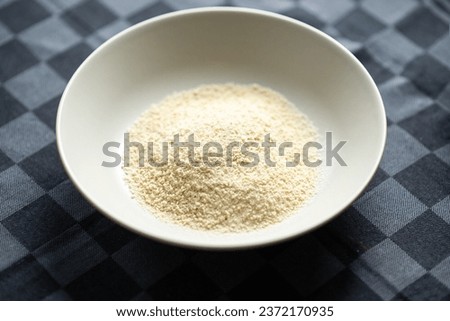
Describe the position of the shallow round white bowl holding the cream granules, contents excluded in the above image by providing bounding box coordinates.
[56,7,386,249]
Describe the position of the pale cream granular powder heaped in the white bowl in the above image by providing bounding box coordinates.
[124,84,318,232]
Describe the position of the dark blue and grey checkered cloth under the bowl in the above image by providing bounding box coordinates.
[0,0,450,300]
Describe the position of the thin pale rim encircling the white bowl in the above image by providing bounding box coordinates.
[55,6,387,250]
